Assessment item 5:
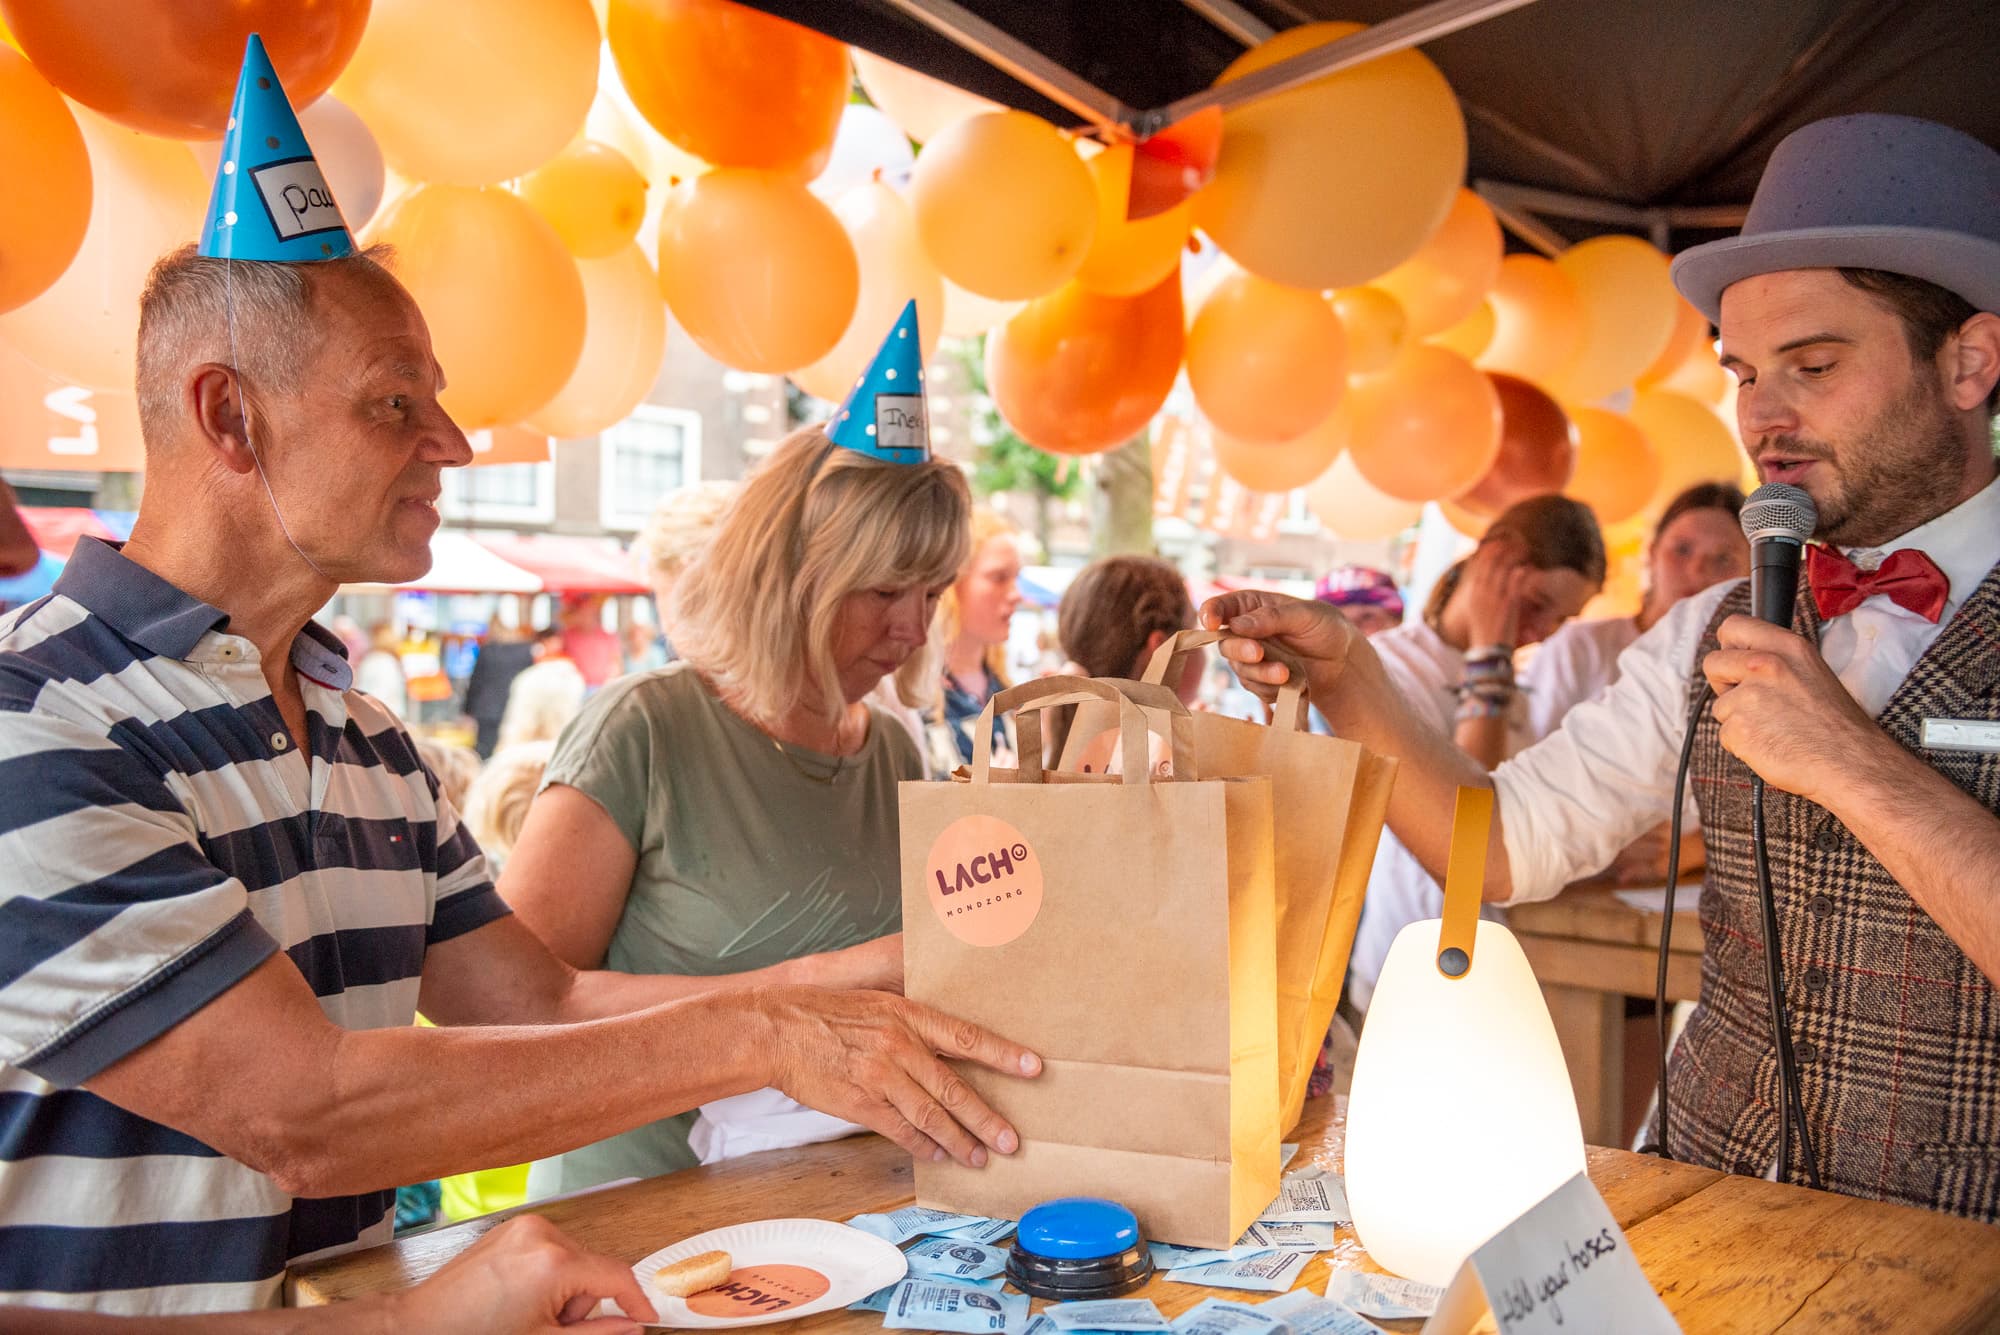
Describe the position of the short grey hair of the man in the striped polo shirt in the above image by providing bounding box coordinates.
[138,246,394,446]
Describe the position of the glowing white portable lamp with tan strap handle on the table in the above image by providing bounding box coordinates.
[1346,787,1584,1285]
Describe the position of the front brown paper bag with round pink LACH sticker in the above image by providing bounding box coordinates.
[902,677,1278,1247]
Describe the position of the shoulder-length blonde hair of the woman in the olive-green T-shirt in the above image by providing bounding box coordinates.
[674,426,972,723]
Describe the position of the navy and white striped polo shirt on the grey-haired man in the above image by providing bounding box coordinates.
[0,540,506,1313]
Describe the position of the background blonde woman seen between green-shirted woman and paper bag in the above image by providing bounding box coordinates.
[932,510,1020,771]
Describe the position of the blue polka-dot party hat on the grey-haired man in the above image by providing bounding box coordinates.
[202,32,354,264]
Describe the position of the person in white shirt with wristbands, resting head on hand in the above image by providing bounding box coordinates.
[1344,496,1604,1011]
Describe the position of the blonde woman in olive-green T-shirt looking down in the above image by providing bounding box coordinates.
[500,428,970,1195]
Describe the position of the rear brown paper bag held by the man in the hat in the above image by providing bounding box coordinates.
[1060,630,1396,1131]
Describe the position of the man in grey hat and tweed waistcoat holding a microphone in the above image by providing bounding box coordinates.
[1204,116,2000,1221]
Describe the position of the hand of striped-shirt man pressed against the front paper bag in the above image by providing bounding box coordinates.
[758,987,1042,1167]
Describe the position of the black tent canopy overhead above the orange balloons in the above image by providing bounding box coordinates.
[752,0,2000,250]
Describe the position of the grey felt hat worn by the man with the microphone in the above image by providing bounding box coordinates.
[1674,112,2000,320]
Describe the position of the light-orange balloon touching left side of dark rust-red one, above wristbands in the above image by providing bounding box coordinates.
[1348,344,1502,502]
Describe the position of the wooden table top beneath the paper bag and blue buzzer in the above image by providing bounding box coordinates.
[286,1099,2000,1335]
